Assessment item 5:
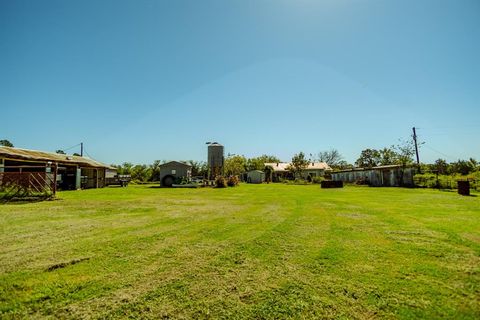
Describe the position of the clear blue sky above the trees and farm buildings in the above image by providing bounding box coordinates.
[0,0,480,163]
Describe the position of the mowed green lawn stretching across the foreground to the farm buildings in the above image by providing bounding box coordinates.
[0,184,480,319]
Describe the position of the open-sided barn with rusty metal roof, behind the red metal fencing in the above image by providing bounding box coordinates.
[0,147,114,190]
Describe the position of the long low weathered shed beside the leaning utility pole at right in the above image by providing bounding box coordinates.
[332,165,416,187]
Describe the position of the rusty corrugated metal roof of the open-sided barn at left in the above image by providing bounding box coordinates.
[0,147,112,168]
